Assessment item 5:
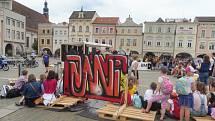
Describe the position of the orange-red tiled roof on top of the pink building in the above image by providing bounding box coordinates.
[93,17,119,24]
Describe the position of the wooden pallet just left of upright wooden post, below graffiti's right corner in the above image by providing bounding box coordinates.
[96,104,120,120]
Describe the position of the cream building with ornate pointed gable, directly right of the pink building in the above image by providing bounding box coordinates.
[115,15,143,54]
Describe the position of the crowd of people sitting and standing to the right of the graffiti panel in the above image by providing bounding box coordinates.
[123,53,215,121]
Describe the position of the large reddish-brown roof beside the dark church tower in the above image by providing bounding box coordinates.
[12,0,49,32]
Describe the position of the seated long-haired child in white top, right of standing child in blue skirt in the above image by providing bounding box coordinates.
[191,82,208,116]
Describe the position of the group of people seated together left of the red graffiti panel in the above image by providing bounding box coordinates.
[7,70,63,107]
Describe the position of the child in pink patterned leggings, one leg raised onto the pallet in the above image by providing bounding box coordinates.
[142,67,172,120]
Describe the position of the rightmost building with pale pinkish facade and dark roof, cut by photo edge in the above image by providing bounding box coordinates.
[195,17,215,56]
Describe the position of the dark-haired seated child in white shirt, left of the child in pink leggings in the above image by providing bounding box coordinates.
[142,82,161,111]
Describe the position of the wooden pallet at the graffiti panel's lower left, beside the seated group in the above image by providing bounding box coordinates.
[49,96,84,107]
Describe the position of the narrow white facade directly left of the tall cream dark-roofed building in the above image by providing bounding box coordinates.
[52,22,69,57]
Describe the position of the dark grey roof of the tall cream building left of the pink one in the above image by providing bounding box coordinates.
[69,11,96,19]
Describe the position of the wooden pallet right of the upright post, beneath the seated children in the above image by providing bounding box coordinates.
[119,107,156,121]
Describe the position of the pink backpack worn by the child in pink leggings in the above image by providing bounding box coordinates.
[161,76,173,95]
